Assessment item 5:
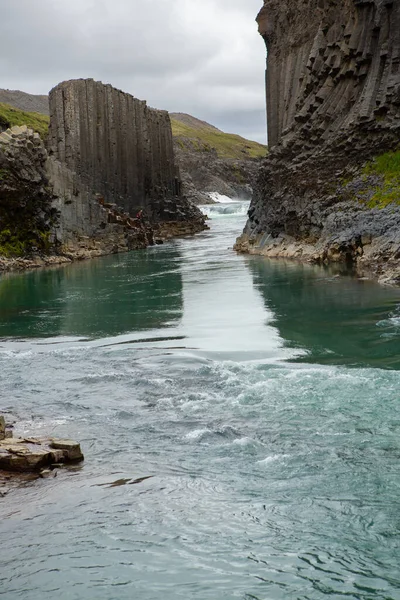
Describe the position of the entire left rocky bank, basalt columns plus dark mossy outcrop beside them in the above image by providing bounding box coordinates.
[0,80,206,271]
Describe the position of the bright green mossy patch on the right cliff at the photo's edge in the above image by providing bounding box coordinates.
[363,150,400,208]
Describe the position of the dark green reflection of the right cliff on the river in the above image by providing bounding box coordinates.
[247,257,400,369]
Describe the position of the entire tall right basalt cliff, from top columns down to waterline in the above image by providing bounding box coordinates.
[236,0,400,281]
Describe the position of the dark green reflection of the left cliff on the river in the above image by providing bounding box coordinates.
[0,245,183,337]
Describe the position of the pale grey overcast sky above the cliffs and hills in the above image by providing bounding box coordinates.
[0,0,266,142]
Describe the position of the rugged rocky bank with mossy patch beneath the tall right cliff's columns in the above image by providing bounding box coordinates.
[235,144,400,285]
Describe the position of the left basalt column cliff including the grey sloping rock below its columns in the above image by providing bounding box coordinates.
[47,79,204,250]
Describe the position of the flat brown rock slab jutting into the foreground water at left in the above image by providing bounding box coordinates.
[0,438,83,473]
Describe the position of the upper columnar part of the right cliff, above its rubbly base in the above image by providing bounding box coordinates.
[258,0,400,146]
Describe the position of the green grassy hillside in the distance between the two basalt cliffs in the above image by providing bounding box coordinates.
[171,118,267,159]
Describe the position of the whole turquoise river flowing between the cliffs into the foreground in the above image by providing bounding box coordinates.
[0,203,400,600]
